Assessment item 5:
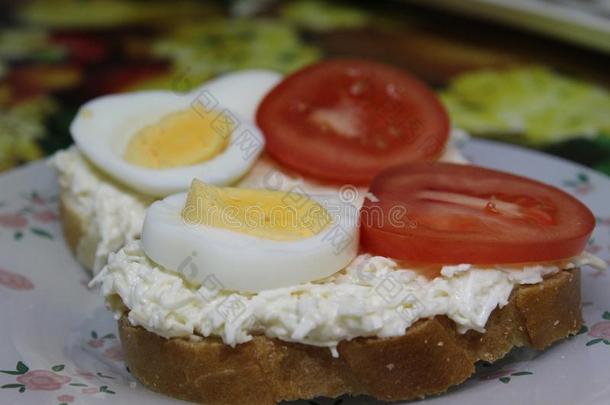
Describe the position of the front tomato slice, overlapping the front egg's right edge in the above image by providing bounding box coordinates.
[360,163,595,264]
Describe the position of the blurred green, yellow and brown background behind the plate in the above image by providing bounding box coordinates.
[0,0,610,175]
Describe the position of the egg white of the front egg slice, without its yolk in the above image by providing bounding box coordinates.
[142,193,358,293]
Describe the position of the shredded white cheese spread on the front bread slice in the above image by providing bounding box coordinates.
[92,242,605,354]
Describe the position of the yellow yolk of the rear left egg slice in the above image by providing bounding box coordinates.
[124,109,234,169]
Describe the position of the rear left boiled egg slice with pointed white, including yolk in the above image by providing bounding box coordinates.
[70,70,279,196]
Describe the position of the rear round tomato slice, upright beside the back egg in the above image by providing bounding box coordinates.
[256,59,449,185]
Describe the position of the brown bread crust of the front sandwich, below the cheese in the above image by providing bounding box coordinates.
[119,269,582,405]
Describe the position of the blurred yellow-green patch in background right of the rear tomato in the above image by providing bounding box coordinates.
[441,66,610,145]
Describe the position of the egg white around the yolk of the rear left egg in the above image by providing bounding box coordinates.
[70,70,281,197]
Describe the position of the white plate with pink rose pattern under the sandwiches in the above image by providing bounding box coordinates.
[0,141,610,405]
